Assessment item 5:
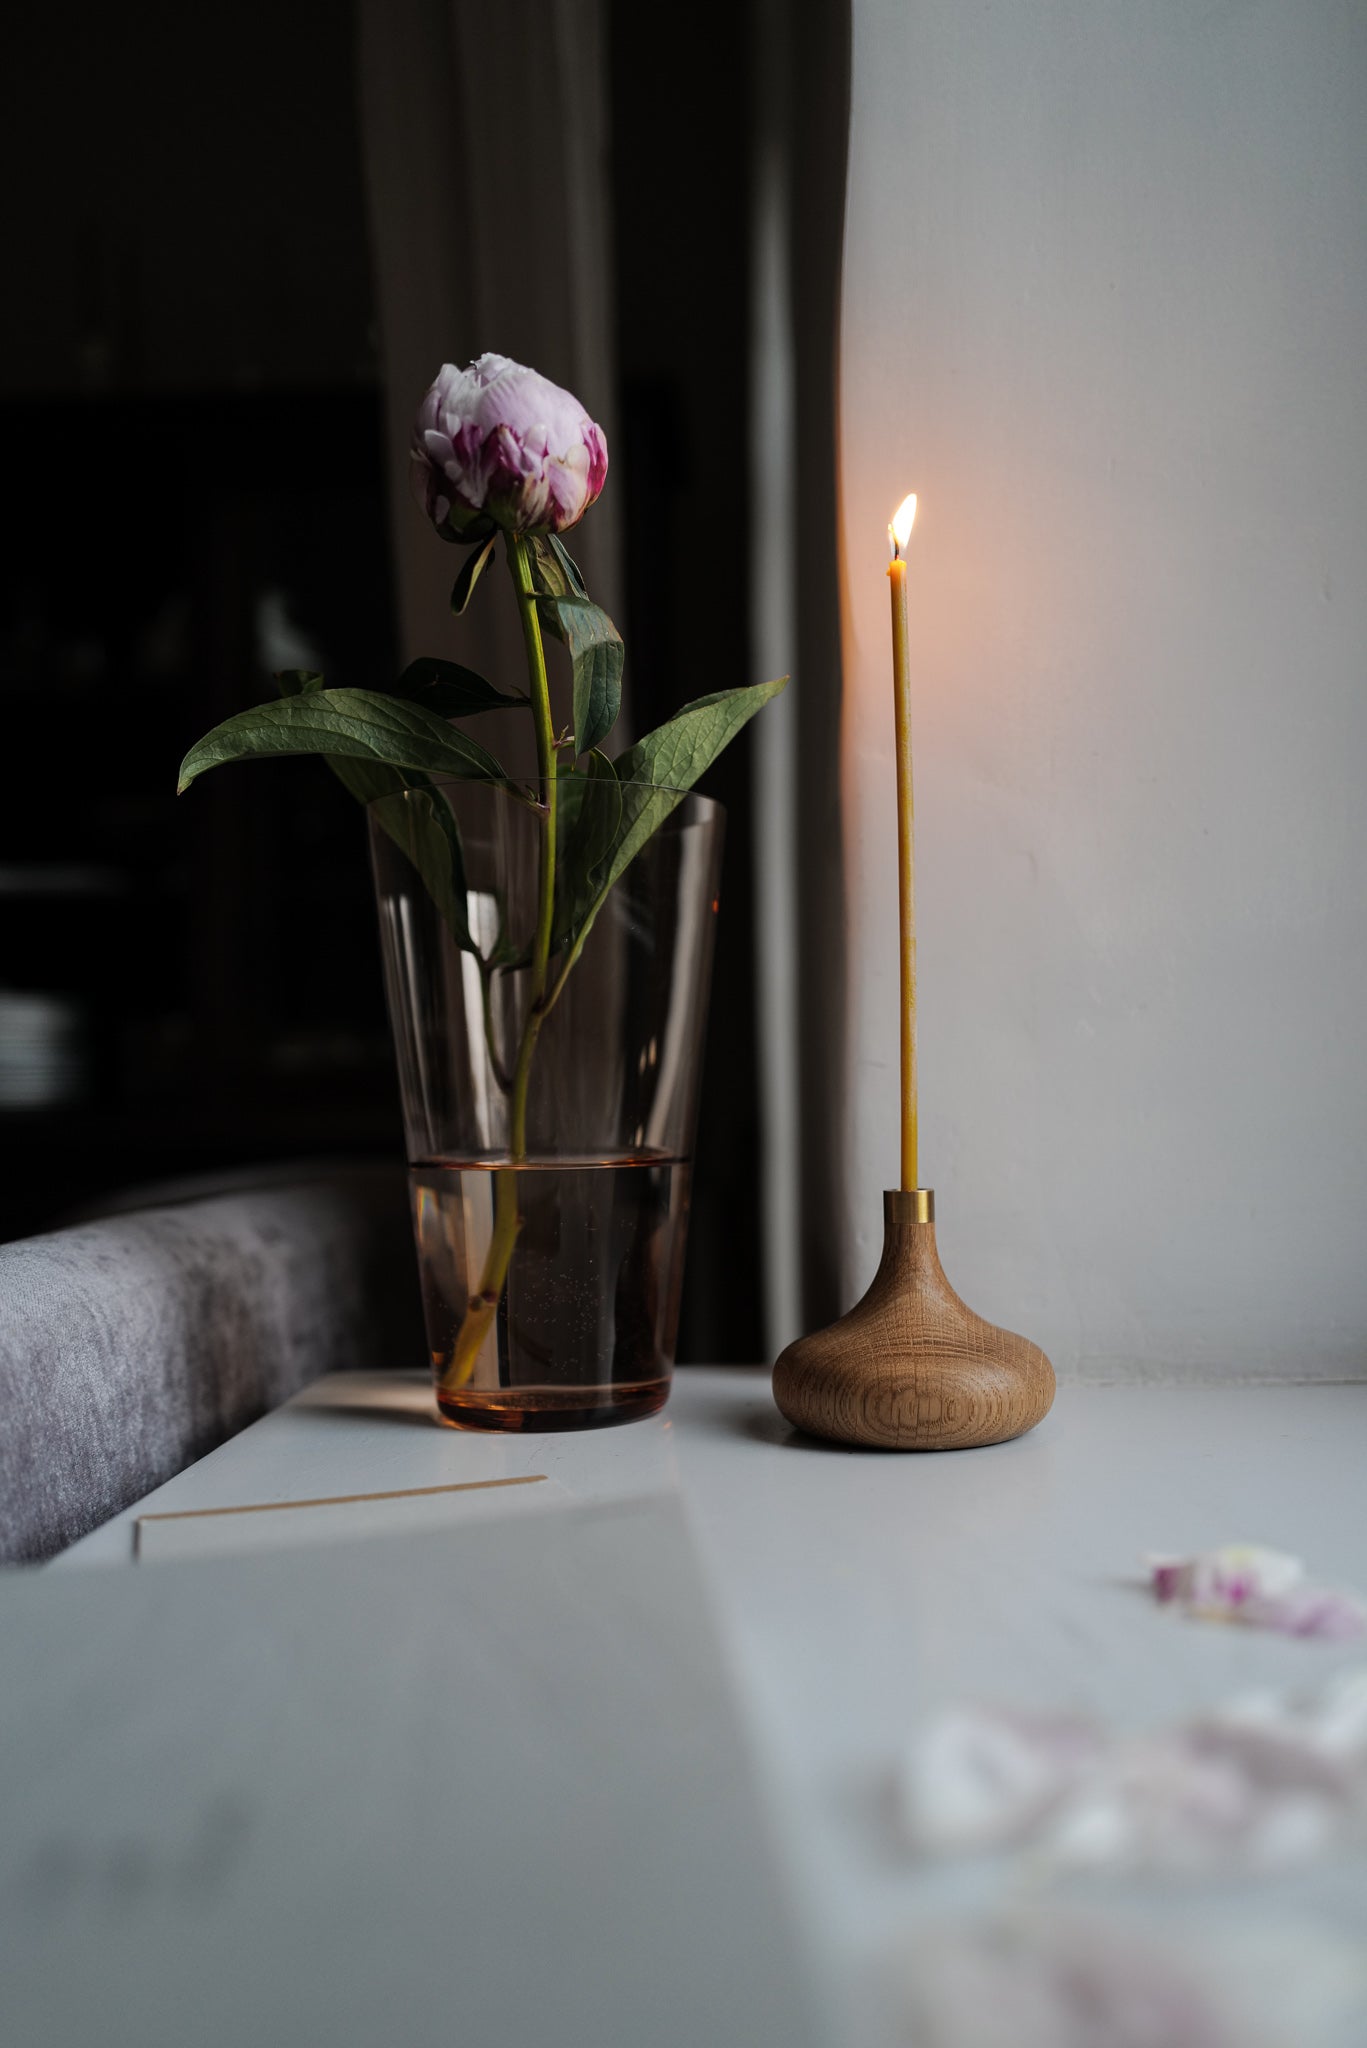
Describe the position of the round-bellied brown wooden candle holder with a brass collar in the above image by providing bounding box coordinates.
[773,1188,1053,1450]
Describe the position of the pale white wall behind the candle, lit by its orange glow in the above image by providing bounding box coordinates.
[840,0,1367,1376]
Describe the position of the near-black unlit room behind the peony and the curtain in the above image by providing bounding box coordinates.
[0,0,762,1360]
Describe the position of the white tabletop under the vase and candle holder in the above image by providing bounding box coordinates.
[51,1368,1367,2025]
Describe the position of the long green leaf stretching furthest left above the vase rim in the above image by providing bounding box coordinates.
[178,688,512,791]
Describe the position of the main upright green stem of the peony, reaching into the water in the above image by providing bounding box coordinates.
[441,532,560,1393]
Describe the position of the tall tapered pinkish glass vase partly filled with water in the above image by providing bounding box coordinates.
[369,782,723,1430]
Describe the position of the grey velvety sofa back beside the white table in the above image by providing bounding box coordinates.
[0,1167,426,1563]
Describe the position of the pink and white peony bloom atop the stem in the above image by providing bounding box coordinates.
[412,356,607,539]
